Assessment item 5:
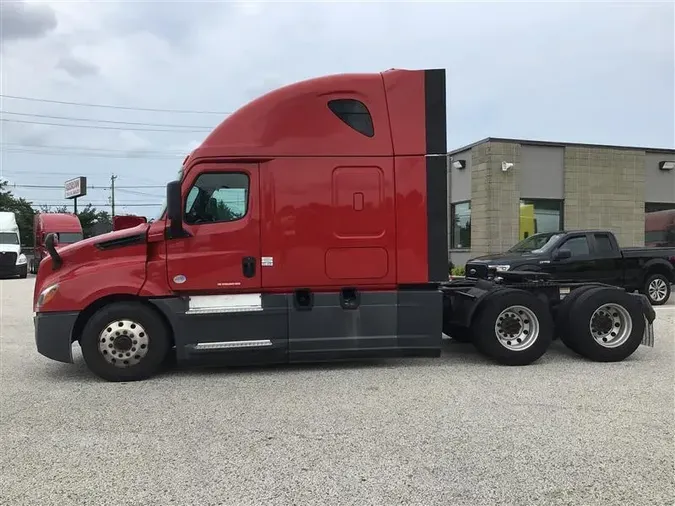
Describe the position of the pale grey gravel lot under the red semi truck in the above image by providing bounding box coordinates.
[0,278,675,506]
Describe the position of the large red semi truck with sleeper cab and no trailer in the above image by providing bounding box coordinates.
[33,69,655,381]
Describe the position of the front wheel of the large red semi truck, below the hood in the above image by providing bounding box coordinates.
[80,302,171,381]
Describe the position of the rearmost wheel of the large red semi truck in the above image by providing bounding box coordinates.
[565,287,645,362]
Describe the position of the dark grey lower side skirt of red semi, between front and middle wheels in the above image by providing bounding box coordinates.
[151,288,443,366]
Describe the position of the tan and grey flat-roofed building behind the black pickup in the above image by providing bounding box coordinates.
[448,137,675,266]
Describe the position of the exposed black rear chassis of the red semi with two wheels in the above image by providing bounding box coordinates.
[440,271,656,365]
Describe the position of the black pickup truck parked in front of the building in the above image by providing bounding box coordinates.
[465,230,675,306]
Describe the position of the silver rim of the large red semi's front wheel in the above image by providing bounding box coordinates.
[98,320,150,368]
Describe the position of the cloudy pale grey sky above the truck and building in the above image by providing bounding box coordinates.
[0,0,675,216]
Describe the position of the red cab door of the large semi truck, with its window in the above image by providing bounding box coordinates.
[167,163,261,294]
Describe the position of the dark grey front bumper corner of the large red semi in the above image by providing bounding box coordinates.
[33,312,80,364]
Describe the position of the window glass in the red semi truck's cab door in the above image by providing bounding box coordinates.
[185,172,249,224]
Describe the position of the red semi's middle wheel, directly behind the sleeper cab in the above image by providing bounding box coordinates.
[471,289,554,365]
